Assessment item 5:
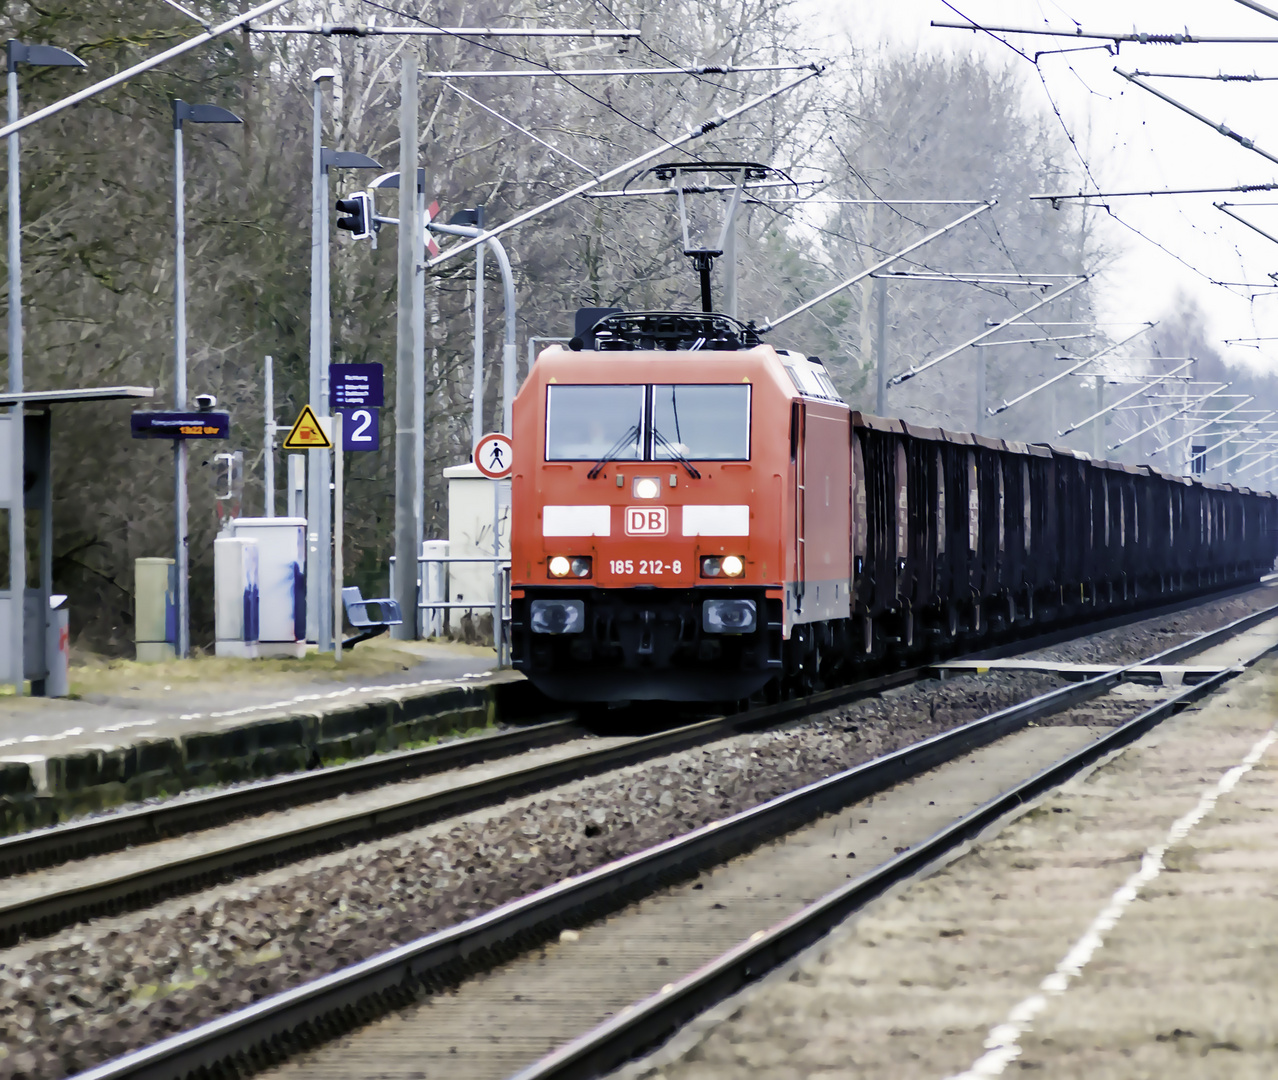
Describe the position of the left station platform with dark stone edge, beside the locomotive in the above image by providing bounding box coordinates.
[0,640,513,835]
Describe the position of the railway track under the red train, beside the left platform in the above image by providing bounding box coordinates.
[7,580,1267,946]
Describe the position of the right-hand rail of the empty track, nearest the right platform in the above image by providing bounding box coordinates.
[511,636,1273,1080]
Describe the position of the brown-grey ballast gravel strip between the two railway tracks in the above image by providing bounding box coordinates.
[0,674,1065,1080]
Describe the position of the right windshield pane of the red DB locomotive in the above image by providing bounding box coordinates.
[649,383,750,461]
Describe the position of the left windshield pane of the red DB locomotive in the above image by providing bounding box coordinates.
[546,386,648,461]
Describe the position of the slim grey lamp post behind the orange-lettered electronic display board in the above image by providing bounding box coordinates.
[173,97,244,658]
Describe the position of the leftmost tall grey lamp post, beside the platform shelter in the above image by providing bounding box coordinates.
[5,37,84,697]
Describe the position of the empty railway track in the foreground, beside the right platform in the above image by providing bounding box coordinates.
[62,598,1278,1080]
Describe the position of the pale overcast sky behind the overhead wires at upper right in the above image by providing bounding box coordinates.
[812,0,1278,368]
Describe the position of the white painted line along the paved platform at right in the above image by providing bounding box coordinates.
[948,727,1278,1080]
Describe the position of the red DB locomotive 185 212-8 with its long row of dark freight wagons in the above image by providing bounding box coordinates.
[511,312,1278,703]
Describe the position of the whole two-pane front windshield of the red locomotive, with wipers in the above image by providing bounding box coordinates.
[546,383,750,461]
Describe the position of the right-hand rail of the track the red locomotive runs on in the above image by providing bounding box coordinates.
[0,667,927,946]
